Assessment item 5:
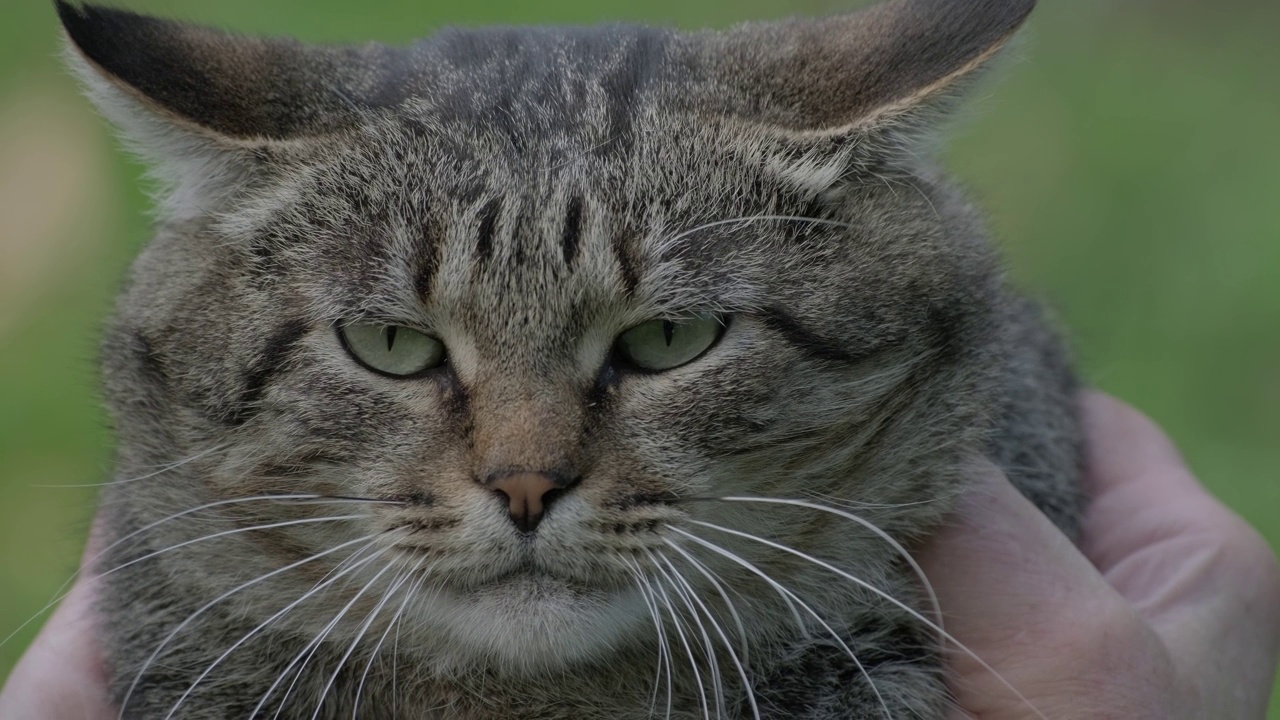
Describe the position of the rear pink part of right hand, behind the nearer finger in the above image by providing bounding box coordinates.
[1082,393,1280,717]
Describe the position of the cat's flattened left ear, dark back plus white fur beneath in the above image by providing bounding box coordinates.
[55,0,401,207]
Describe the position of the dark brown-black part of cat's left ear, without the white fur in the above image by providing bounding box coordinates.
[56,0,402,140]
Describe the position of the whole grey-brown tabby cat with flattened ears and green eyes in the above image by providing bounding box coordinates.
[56,0,1080,720]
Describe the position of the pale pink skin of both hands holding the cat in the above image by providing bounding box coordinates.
[0,393,1280,720]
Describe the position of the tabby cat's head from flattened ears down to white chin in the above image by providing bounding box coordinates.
[59,0,1033,667]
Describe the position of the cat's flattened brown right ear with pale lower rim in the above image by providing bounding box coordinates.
[712,0,1036,137]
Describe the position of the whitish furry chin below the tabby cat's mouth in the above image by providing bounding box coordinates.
[417,573,652,674]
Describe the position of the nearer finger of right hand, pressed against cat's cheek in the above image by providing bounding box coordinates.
[922,464,1175,720]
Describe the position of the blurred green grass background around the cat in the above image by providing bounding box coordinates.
[0,0,1280,707]
